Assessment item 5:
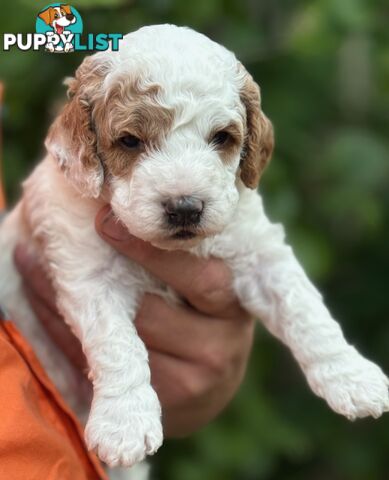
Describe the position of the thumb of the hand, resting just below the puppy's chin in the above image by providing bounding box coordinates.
[96,207,246,318]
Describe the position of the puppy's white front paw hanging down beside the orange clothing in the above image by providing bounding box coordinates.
[85,385,163,467]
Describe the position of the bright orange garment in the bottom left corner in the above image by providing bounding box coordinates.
[0,319,107,480]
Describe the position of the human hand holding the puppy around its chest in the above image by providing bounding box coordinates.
[15,207,254,436]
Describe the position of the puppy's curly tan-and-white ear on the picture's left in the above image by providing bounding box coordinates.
[45,57,104,198]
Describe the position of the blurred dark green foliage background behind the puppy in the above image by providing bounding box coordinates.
[0,0,389,480]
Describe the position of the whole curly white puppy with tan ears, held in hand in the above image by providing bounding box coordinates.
[0,25,389,472]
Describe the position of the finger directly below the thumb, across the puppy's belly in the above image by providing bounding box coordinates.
[135,294,253,368]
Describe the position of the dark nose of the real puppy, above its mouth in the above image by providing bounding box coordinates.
[164,197,204,227]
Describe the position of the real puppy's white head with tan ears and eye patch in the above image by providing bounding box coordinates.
[46,25,273,249]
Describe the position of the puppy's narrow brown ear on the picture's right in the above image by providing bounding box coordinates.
[240,67,274,189]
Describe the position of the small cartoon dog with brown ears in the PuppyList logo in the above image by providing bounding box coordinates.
[38,4,77,52]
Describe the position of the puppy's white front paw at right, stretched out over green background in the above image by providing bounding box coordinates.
[308,349,389,420]
